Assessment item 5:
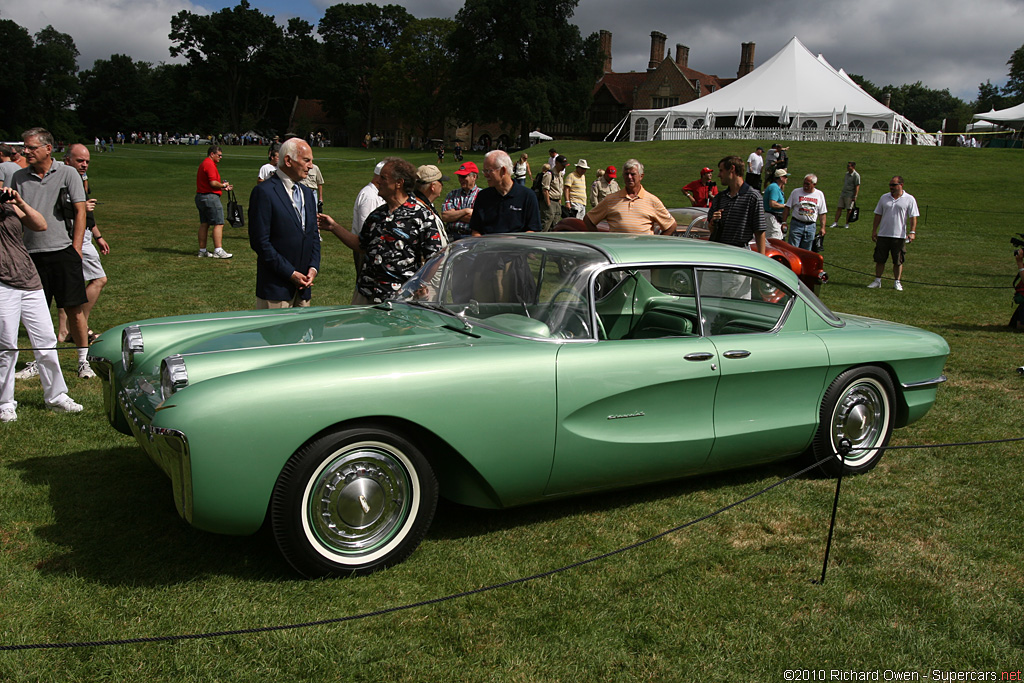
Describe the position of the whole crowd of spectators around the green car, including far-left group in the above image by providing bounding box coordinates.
[0,128,919,422]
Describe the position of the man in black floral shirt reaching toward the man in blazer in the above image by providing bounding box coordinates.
[318,157,441,305]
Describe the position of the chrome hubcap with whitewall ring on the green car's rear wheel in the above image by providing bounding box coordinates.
[829,378,891,467]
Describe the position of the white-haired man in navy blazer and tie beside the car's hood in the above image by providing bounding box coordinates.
[249,137,321,308]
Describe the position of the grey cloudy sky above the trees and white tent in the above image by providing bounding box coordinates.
[0,0,1024,101]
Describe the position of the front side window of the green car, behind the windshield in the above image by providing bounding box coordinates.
[595,266,700,340]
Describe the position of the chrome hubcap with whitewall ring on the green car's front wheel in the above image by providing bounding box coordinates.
[302,441,420,564]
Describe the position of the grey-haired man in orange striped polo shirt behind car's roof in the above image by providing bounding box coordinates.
[583,159,676,234]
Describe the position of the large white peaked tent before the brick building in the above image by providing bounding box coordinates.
[624,37,935,144]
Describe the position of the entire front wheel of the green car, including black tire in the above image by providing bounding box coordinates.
[270,426,437,577]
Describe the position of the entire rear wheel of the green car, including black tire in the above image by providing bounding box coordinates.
[814,367,895,476]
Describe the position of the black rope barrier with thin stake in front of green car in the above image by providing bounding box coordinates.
[0,437,1024,652]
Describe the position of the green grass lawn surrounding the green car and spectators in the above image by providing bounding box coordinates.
[0,141,1024,682]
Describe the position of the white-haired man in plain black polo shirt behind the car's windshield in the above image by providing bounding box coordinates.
[469,150,541,237]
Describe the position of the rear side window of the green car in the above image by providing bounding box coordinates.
[697,269,794,335]
